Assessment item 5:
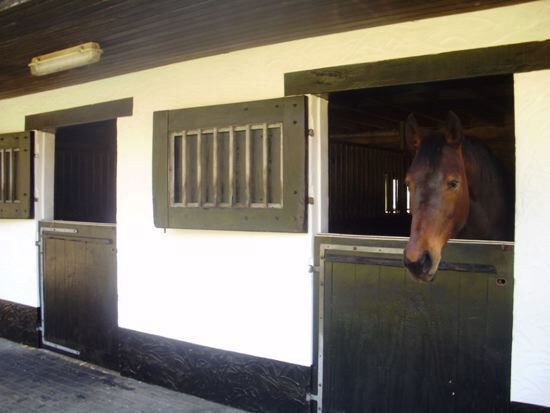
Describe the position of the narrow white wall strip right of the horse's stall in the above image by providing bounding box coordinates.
[512,70,550,406]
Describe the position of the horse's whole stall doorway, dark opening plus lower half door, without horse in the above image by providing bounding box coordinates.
[322,75,515,413]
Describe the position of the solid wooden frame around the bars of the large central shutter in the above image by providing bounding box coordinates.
[153,96,308,232]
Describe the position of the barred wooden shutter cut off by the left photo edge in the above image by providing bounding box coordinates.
[0,132,33,218]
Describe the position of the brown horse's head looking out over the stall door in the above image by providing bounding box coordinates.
[403,112,470,282]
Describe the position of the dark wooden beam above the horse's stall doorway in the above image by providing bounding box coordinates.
[285,40,550,96]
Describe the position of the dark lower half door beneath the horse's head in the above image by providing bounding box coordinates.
[317,237,513,413]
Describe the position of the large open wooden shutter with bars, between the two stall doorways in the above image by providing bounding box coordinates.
[153,96,307,232]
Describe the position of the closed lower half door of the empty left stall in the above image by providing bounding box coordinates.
[40,221,118,368]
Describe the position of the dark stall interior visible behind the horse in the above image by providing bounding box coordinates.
[329,75,515,236]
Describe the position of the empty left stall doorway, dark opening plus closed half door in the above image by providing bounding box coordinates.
[40,120,118,368]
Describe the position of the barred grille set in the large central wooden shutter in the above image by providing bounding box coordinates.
[169,123,283,208]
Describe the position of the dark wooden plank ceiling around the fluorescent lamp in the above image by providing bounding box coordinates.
[0,0,536,99]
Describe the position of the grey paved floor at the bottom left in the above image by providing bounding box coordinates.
[0,338,250,413]
